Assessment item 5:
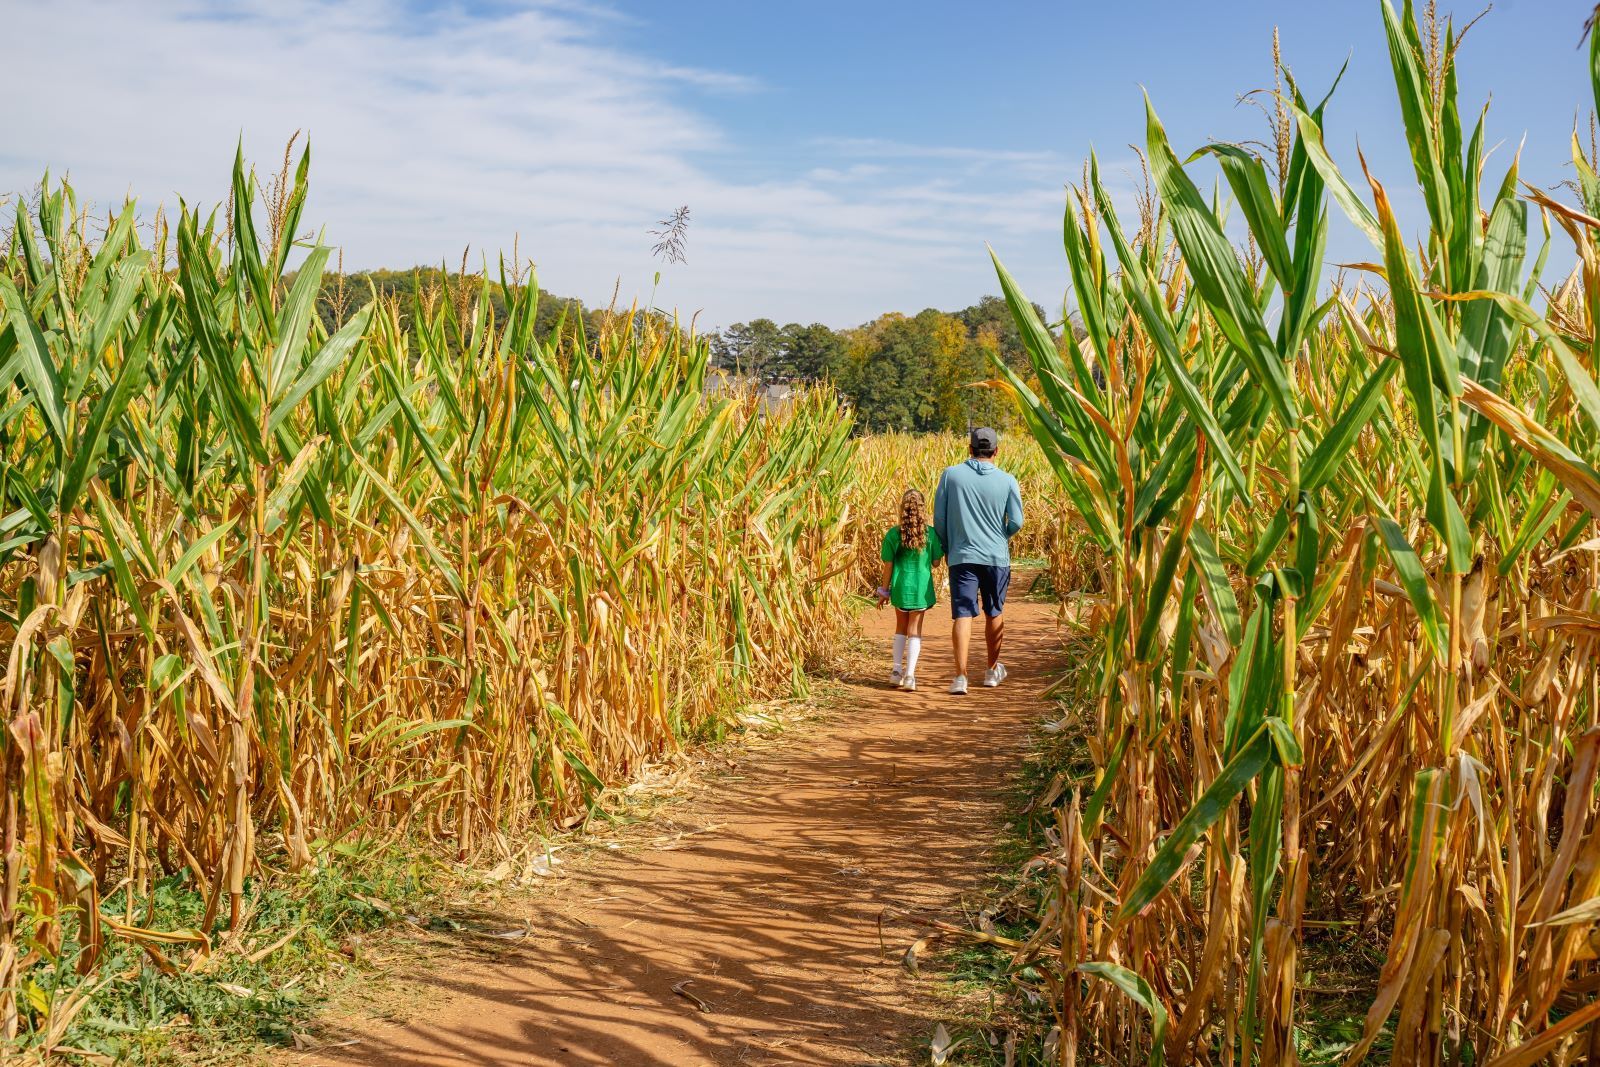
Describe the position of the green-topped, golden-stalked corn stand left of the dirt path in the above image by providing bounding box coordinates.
[0,154,851,1037]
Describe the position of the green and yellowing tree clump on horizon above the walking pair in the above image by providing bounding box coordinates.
[710,296,1043,432]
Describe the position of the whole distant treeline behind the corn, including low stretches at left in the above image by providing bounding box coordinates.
[318,267,1043,432]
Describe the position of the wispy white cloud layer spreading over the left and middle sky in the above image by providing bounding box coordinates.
[0,0,1077,325]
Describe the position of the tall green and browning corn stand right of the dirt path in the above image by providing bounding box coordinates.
[1000,0,1600,1067]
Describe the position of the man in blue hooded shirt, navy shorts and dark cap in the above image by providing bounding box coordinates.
[933,426,1022,694]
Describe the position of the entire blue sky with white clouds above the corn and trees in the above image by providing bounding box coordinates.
[0,0,1592,326]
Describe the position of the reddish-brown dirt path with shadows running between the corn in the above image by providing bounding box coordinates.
[307,579,1059,1067]
